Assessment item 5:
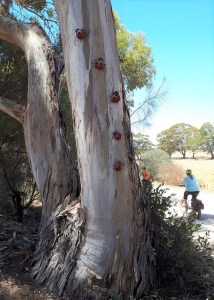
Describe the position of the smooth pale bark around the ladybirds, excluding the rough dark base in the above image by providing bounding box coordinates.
[54,0,134,276]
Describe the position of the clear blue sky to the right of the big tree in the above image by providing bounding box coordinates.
[111,0,214,142]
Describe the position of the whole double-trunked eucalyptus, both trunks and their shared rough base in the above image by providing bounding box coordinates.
[0,0,154,300]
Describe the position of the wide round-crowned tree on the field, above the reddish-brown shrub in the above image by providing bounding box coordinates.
[158,123,197,158]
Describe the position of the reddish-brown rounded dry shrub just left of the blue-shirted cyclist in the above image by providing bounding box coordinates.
[158,162,185,185]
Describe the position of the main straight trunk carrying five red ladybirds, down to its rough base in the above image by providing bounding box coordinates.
[54,0,153,297]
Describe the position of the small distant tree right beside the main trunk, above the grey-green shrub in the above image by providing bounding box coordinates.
[133,133,154,160]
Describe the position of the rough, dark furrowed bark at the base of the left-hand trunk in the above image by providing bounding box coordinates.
[32,201,85,295]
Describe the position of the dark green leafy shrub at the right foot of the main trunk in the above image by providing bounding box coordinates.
[145,186,214,300]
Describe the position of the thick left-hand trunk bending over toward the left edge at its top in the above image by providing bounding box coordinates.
[0,16,78,215]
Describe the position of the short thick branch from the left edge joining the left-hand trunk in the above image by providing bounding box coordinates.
[0,97,26,125]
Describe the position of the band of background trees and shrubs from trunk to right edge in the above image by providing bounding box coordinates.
[134,122,214,185]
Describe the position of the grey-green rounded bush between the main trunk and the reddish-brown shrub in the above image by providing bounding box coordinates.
[140,149,171,180]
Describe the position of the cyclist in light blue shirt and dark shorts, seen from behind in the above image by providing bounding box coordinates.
[183,169,200,201]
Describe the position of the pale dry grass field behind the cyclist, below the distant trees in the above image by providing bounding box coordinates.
[172,153,214,192]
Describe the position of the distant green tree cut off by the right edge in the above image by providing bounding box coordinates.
[200,122,214,159]
